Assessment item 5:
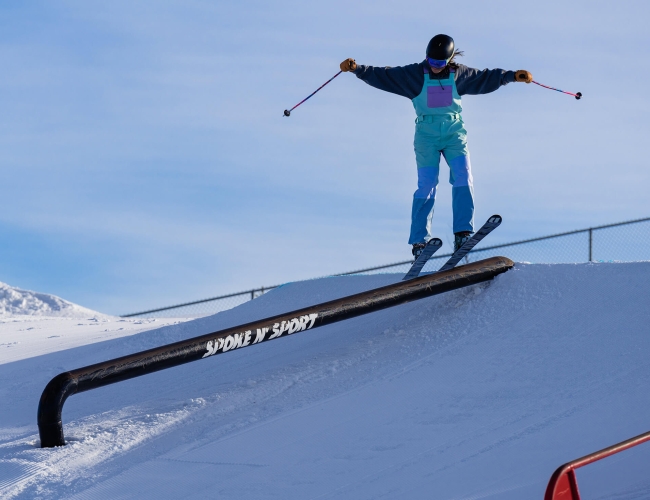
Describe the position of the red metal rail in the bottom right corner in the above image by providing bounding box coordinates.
[544,432,650,500]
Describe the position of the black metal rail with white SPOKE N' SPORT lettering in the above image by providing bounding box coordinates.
[38,257,514,448]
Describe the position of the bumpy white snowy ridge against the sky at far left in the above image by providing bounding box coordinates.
[0,282,105,318]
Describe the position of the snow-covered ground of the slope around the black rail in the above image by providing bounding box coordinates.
[0,262,650,500]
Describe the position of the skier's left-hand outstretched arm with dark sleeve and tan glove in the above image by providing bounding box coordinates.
[340,58,424,99]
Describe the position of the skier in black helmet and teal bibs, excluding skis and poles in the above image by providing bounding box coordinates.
[341,35,533,258]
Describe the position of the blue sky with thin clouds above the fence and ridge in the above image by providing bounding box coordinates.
[0,0,650,314]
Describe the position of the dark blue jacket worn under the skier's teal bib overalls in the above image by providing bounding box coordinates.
[354,60,515,99]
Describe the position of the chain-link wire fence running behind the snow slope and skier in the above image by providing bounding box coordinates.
[122,217,650,318]
